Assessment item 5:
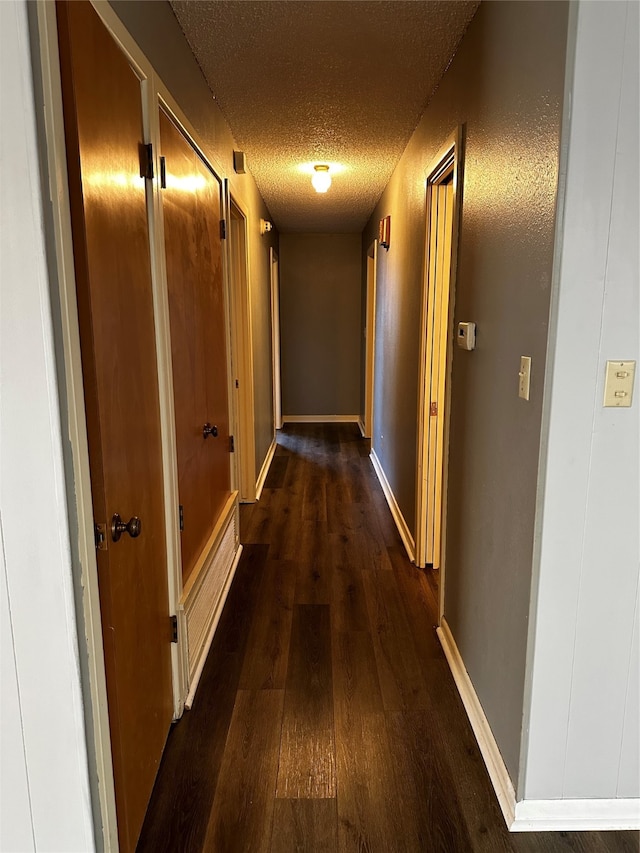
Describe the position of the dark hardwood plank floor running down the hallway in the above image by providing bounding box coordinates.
[138,424,640,853]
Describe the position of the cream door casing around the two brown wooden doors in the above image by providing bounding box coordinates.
[31,5,236,851]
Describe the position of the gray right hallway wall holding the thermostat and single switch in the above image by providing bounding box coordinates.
[363,2,568,782]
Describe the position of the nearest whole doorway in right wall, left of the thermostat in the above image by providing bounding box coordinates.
[416,135,460,584]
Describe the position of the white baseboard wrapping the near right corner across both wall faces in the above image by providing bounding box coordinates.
[438,618,640,832]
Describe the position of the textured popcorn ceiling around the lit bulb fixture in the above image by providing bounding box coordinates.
[171,0,479,232]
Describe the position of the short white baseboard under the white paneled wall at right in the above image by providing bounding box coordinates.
[509,798,640,832]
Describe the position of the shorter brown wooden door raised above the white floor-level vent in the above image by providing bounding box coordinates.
[160,110,231,581]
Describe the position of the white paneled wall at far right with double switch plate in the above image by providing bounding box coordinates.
[524,2,640,799]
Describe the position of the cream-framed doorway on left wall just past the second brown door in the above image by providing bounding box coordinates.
[225,188,256,502]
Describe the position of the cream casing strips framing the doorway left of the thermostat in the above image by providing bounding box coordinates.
[416,128,462,616]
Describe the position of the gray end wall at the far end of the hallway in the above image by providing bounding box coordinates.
[280,234,362,418]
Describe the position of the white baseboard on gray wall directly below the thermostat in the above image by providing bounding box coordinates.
[437,616,516,830]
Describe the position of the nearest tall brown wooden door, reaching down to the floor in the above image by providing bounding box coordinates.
[58,2,173,851]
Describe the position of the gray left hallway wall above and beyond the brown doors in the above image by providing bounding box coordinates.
[110,0,278,480]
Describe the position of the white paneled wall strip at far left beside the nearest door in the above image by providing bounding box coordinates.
[0,2,94,853]
